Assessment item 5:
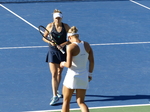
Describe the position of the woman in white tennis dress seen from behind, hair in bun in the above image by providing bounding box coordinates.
[60,26,94,112]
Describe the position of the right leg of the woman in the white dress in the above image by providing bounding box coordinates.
[76,89,89,112]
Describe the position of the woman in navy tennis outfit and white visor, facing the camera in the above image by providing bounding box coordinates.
[43,9,70,105]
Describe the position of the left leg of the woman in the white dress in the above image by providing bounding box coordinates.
[62,86,74,112]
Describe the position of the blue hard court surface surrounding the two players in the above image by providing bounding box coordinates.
[0,0,150,112]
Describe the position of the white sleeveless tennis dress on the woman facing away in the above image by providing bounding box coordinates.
[63,41,89,89]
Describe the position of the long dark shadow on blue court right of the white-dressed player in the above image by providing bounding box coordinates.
[85,95,150,102]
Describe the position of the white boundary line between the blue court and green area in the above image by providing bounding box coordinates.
[23,104,150,112]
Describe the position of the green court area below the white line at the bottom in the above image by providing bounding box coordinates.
[45,105,150,112]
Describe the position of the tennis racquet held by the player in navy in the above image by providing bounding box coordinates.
[39,25,65,54]
